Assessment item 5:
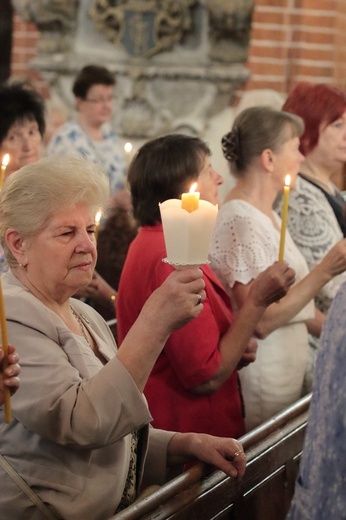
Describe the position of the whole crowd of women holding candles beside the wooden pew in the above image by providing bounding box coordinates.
[0,70,346,520]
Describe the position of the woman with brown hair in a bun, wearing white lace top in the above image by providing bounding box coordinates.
[210,107,346,429]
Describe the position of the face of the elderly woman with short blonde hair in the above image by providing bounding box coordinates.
[24,205,97,301]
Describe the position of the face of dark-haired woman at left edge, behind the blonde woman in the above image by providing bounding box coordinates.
[0,119,41,173]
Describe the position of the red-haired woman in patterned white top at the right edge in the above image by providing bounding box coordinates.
[275,82,346,391]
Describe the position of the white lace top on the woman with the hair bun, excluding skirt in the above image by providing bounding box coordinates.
[210,200,313,321]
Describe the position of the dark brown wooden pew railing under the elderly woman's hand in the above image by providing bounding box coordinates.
[110,394,311,520]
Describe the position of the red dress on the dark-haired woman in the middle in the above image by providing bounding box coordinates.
[117,224,245,437]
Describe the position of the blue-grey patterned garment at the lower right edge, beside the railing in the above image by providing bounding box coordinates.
[288,284,346,520]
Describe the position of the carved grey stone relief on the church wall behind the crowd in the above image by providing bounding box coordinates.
[14,0,253,139]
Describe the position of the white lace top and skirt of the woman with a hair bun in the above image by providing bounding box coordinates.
[210,200,314,431]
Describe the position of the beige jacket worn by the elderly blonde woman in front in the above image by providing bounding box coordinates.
[0,272,173,520]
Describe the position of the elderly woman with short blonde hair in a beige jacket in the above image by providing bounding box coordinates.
[0,156,245,520]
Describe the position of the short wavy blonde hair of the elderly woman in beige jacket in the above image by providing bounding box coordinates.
[0,155,109,266]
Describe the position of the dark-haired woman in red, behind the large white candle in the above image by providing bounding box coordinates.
[117,135,293,437]
